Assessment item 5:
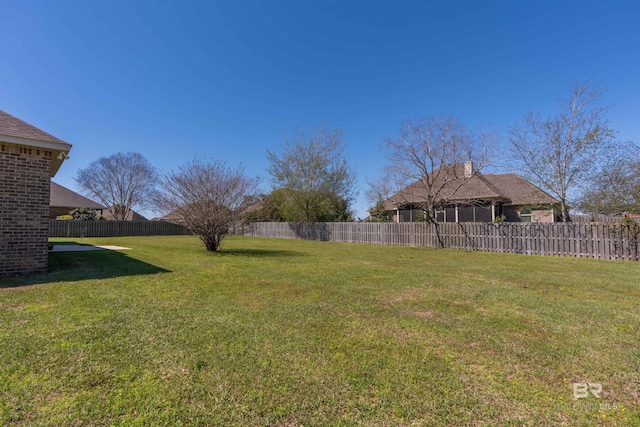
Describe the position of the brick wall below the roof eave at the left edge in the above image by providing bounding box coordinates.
[0,142,52,275]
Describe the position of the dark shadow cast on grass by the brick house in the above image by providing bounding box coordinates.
[0,249,169,288]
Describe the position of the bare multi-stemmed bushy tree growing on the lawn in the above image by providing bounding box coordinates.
[156,159,258,251]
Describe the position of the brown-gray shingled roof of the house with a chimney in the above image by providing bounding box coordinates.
[384,165,559,210]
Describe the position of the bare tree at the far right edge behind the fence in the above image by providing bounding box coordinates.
[578,144,640,215]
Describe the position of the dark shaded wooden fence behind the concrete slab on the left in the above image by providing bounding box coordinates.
[49,219,190,237]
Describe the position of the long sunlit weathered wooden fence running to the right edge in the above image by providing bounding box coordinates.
[234,222,640,261]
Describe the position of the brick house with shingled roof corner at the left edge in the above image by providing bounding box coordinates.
[0,110,71,276]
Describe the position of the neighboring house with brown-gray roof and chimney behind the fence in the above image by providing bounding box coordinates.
[384,162,560,222]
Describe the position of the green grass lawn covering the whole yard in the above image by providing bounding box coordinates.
[0,236,640,426]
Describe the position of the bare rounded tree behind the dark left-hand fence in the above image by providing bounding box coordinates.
[75,153,158,220]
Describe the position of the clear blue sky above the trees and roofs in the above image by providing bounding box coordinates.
[0,0,640,216]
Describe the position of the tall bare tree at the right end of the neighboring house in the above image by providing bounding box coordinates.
[509,80,615,222]
